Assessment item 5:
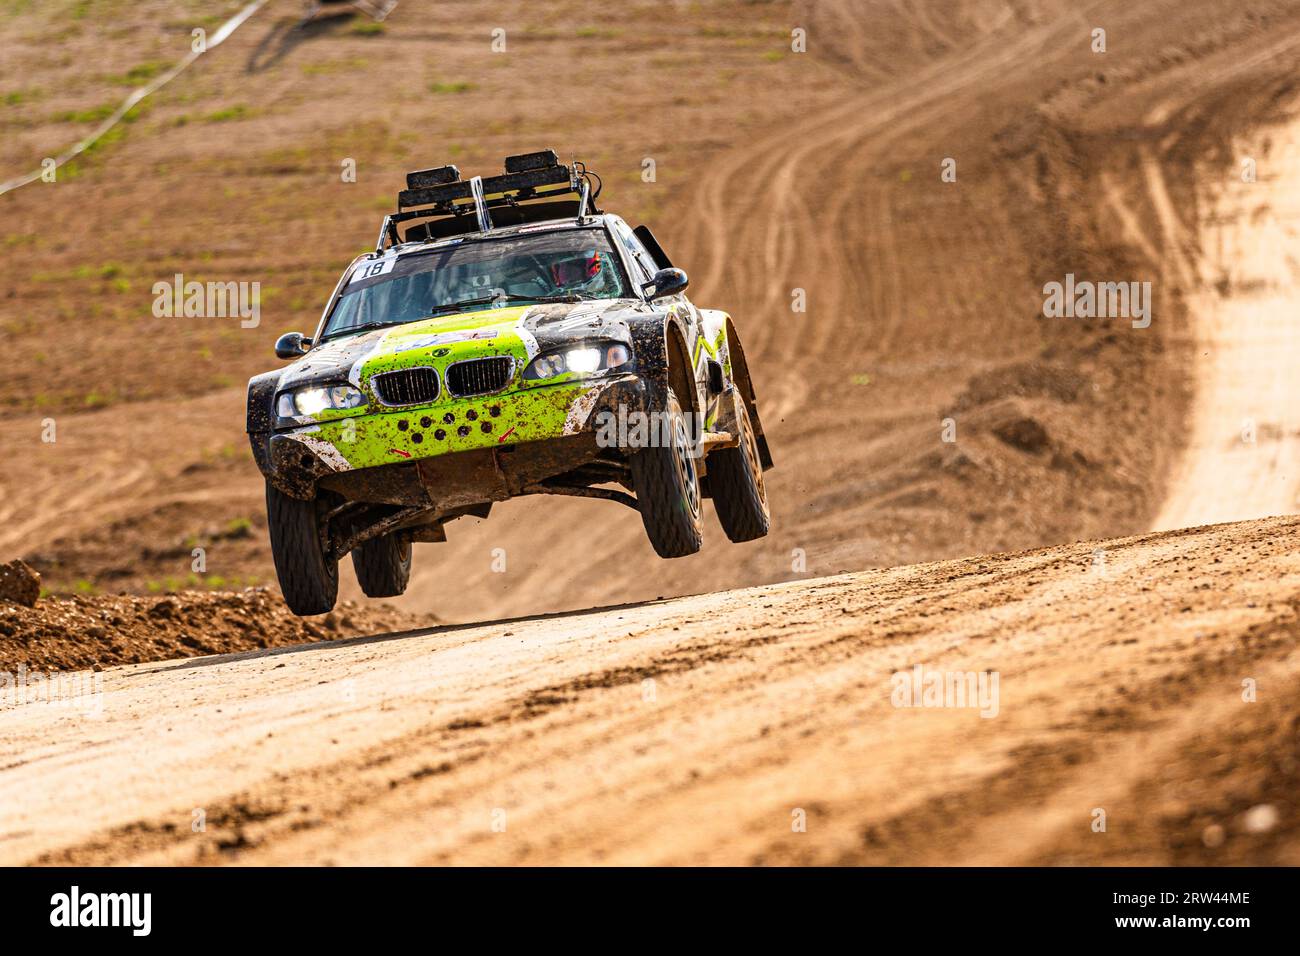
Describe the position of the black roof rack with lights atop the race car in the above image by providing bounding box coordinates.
[374,150,601,255]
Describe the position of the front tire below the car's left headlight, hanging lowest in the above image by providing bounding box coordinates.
[267,481,338,617]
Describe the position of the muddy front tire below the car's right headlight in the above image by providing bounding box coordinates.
[632,388,705,558]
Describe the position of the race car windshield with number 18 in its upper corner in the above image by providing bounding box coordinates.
[322,228,629,338]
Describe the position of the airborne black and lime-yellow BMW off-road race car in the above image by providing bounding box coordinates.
[247,150,772,614]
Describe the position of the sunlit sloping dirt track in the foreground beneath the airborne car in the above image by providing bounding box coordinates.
[0,519,1300,865]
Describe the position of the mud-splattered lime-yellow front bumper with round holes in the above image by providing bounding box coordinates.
[264,373,646,497]
